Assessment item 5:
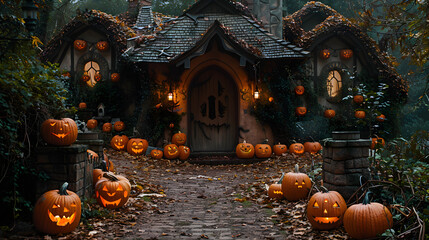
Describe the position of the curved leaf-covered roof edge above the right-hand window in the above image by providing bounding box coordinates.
[284,1,408,100]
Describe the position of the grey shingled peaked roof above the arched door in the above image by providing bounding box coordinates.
[124,0,308,62]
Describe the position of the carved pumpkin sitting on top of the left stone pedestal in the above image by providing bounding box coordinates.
[40,118,77,146]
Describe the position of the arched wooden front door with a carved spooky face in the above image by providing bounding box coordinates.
[189,67,238,152]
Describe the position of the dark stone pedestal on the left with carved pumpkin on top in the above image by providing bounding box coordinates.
[36,144,93,199]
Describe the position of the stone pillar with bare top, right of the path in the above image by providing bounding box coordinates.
[323,131,371,201]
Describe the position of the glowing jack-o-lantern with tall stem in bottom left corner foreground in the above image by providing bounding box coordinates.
[33,182,81,234]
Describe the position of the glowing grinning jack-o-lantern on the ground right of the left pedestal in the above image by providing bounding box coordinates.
[95,173,131,209]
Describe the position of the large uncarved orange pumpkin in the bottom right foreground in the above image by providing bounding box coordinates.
[343,192,393,239]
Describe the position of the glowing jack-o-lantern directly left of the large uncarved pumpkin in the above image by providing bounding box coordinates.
[307,191,347,230]
